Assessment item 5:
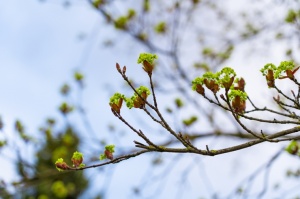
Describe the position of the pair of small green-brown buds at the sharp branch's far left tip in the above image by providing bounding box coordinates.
[55,151,85,171]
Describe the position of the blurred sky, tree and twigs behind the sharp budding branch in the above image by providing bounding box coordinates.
[0,0,300,199]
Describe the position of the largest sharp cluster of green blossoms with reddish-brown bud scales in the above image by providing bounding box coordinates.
[192,67,247,114]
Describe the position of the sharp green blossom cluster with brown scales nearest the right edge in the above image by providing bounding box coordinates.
[260,61,299,88]
